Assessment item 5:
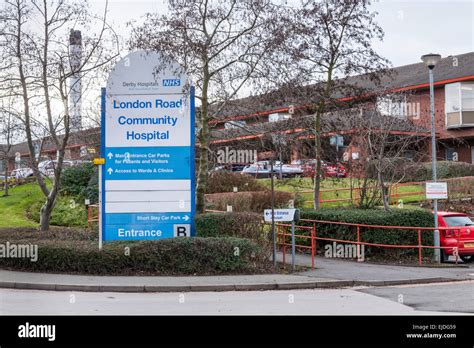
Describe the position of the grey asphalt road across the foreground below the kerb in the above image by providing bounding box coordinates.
[0,282,474,315]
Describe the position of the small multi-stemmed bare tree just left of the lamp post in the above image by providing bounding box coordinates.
[345,92,429,210]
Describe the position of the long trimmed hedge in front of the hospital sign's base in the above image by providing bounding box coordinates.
[0,230,269,275]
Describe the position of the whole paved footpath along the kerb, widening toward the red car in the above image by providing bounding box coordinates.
[0,255,474,292]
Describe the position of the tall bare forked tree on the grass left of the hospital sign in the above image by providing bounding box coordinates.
[0,0,118,231]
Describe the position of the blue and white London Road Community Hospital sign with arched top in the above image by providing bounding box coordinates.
[101,51,194,240]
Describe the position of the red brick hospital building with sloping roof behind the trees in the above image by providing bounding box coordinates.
[3,52,474,170]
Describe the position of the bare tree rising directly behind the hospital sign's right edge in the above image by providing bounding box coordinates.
[130,0,286,212]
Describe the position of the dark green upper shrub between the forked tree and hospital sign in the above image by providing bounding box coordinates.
[59,163,94,199]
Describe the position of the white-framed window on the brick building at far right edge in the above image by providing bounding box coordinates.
[444,82,474,128]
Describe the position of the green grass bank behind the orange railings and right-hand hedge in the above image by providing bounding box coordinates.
[259,178,424,208]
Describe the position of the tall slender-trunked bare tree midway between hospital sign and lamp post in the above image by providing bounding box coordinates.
[291,0,387,209]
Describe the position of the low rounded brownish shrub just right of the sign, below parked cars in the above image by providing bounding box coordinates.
[206,171,265,193]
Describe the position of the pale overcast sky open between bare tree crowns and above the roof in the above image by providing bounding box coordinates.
[91,0,474,66]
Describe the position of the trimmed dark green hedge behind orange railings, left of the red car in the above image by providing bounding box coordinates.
[290,209,434,256]
